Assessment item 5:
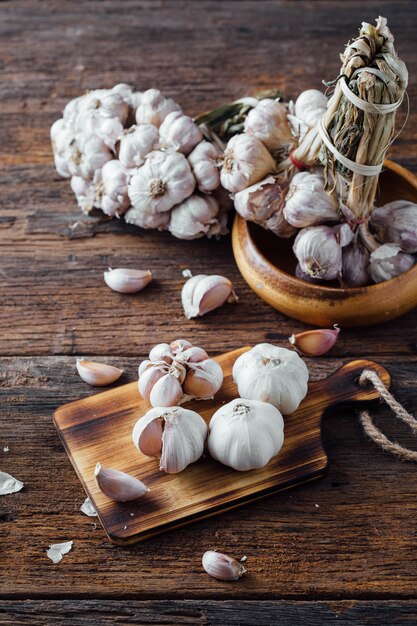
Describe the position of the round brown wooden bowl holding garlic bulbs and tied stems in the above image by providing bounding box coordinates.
[232,161,417,327]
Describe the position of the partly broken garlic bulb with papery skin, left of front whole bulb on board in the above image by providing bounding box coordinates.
[132,407,207,474]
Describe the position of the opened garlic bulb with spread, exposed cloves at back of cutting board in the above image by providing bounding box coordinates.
[138,339,223,407]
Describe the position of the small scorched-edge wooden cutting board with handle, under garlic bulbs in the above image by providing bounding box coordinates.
[54,348,390,545]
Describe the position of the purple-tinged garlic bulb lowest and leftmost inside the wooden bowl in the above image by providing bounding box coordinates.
[293,224,353,280]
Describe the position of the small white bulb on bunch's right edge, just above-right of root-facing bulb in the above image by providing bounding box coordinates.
[159,111,203,155]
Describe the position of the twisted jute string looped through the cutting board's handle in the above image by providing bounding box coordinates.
[359,369,417,462]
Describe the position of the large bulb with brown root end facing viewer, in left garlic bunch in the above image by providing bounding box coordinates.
[128,150,195,214]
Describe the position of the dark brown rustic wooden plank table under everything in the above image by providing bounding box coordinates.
[0,0,417,626]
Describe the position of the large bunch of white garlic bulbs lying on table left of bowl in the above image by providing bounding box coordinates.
[51,84,228,239]
